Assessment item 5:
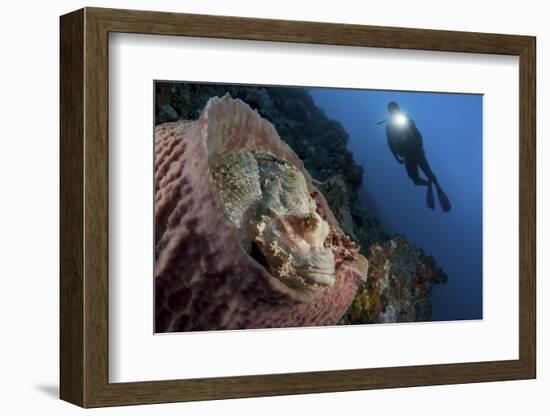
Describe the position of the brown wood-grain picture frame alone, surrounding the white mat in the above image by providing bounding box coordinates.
[60,8,536,407]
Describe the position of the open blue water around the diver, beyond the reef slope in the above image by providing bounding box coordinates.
[310,88,483,320]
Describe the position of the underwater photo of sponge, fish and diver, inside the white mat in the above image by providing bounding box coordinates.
[153,81,483,333]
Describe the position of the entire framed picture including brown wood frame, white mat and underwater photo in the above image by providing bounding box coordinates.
[60,8,536,407]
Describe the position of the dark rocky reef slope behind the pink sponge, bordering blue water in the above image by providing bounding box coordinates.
[155,82,447,324]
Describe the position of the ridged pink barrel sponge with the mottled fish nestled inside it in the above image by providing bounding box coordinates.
[154,95,367,332]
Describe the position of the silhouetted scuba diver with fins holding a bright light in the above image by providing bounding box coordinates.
[378,101,451,212]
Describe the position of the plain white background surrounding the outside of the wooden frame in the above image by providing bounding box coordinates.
[0,0,550,416]
